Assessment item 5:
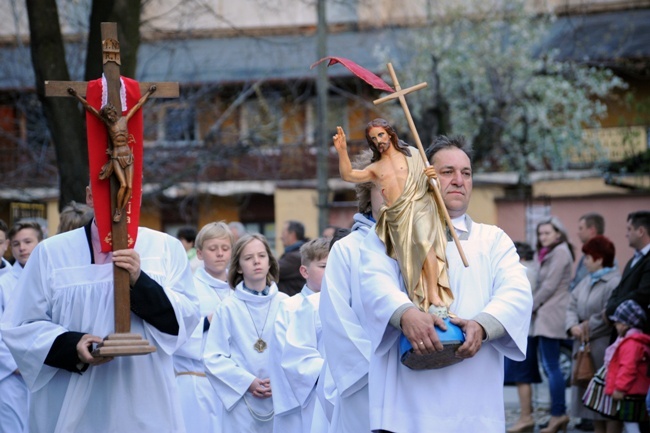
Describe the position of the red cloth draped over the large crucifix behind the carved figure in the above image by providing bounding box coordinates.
[86,77,143,252]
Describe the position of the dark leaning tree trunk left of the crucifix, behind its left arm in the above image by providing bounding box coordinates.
[27,0,88,209]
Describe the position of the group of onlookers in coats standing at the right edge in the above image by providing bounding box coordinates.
[506,211,650,433]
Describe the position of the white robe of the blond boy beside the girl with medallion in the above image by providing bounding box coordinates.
[174,262,233,433]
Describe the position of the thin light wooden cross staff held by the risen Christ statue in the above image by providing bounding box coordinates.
[373,63,469,267]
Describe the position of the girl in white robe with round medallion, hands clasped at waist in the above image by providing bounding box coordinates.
[203,234,287,433]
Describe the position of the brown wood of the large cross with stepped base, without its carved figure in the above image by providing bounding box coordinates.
[45,23,179,356]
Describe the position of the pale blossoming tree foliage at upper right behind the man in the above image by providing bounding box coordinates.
[395,0,626,178]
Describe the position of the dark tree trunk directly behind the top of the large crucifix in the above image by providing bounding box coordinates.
[85,0,142,81]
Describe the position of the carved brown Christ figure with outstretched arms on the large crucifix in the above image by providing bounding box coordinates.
[68,85,156,222]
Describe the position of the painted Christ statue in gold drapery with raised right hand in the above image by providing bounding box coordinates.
[333,119,453,317]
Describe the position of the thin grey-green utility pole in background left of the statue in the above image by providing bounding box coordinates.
[316,0,330,235]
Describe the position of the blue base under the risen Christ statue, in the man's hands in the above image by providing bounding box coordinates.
[399,318,465,370]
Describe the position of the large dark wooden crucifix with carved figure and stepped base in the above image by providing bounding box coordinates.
[45,23,179,357]
